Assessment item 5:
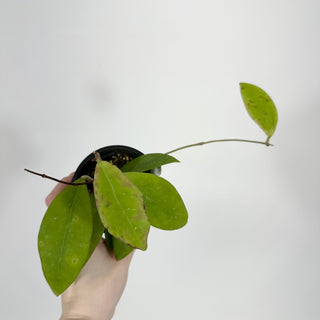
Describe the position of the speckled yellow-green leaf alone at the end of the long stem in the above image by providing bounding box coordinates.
[240,83,278,140]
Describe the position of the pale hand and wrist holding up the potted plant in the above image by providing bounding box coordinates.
[46,173,133,320]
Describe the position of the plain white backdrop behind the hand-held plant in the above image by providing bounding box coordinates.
[0,0,320,320]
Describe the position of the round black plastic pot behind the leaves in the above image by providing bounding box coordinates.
[72,145,143,181]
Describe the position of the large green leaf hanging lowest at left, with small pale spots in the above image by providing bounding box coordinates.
[38,179,92,295]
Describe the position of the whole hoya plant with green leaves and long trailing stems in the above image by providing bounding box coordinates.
[25,83,278,295]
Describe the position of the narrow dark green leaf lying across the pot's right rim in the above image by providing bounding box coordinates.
[121,153,179,172]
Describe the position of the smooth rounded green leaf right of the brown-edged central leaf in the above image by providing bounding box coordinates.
[126,172,188,230]
